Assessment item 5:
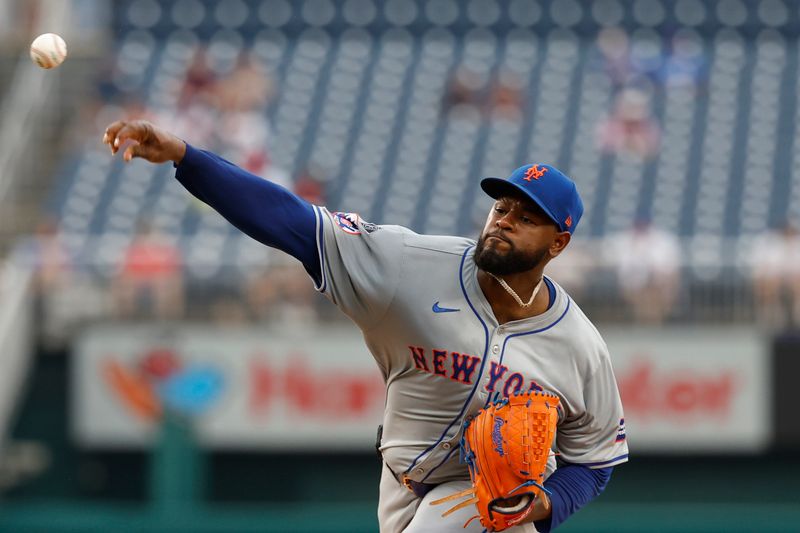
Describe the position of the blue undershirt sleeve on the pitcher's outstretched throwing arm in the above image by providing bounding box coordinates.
[175,143,322,284]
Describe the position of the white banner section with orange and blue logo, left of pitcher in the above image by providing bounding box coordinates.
[72,327,385,450]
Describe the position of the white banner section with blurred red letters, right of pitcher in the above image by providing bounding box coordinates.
[603,328,771,453]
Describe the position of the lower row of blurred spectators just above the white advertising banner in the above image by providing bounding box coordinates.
[18,211,800,354]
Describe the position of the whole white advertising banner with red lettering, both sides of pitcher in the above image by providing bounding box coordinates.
[72,326,772,454]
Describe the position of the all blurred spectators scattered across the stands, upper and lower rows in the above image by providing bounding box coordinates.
[17,22,800,350]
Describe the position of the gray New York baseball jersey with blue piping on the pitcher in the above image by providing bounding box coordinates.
[315,208,628,530]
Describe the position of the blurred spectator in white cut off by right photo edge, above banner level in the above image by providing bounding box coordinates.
[752,223,800,328]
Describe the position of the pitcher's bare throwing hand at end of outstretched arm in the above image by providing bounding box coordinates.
[103,120,186,164]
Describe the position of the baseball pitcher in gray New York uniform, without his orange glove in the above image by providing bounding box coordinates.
[103,121,628,533]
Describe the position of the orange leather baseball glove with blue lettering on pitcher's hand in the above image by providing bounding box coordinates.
[431,391,559,531]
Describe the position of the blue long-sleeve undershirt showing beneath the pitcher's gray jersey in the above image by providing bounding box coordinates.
[175,144,613,532]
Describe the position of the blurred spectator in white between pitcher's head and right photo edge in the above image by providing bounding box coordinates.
[609,217,681,324]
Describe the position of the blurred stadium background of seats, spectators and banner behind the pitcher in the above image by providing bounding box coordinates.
[0,0,800,532]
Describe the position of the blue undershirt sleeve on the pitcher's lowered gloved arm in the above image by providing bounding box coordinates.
[534,464,614,533]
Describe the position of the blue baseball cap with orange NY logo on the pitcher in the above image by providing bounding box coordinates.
[481,163,583,233]
